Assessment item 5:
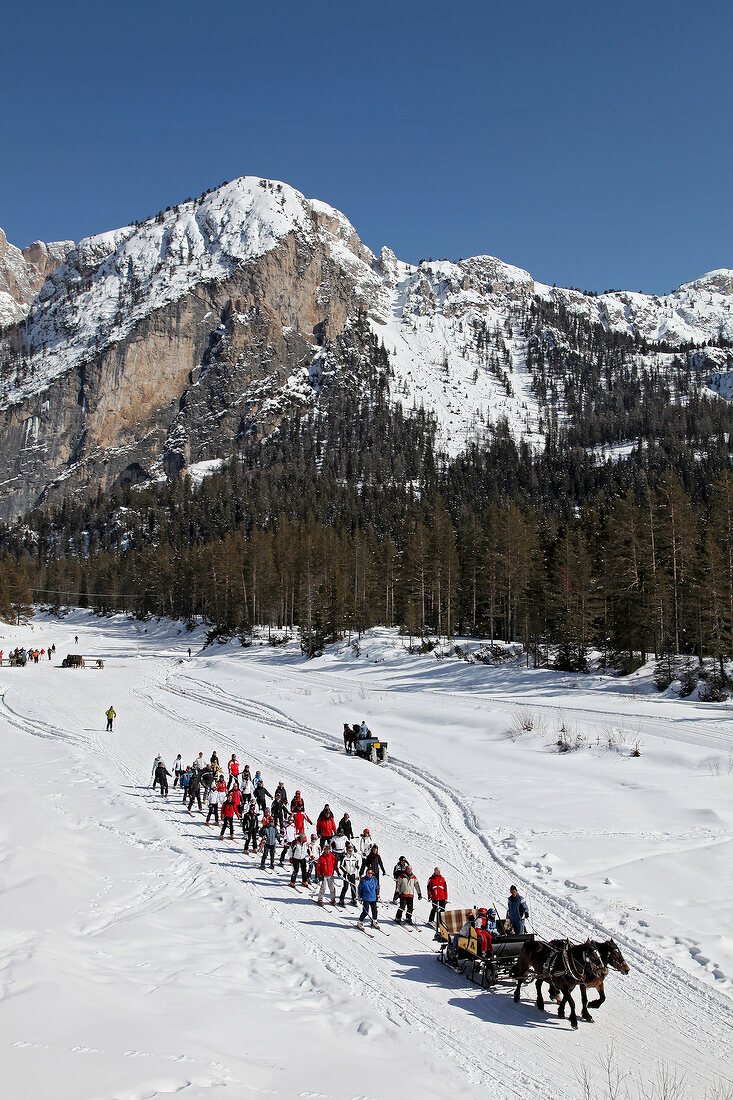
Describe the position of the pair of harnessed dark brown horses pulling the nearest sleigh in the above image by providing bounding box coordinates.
[512,939,628,1027]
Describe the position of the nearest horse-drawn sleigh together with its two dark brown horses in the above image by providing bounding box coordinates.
[438,909,628,1027]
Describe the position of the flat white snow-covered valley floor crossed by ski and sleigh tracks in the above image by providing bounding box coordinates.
[0,613,733,1100]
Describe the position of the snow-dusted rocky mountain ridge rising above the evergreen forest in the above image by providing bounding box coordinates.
[0,178,733,519]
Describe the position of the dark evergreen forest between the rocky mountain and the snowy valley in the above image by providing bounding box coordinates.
[0,306,733,697]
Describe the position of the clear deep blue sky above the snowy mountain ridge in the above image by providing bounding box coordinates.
[0,0,733,292]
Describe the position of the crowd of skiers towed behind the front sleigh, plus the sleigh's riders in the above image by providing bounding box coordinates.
[147,751,528,938]
